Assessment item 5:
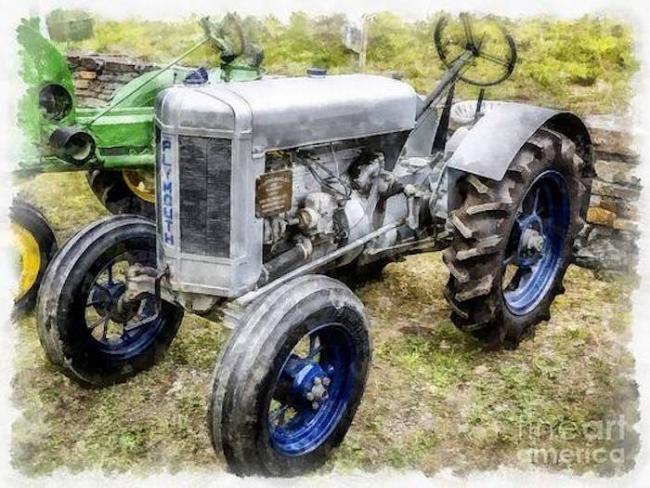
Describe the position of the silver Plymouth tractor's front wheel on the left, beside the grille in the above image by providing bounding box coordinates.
[37,215,183,386]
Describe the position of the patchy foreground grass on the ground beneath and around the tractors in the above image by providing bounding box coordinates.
[12,173,639,475]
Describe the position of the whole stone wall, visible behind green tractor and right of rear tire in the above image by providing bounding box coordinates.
[63,54,641,271]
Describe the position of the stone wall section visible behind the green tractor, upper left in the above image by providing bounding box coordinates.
[68,54,157,107]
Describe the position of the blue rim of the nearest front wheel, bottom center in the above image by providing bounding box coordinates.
[267,323,356,456]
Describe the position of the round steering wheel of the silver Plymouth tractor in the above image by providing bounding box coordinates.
[433,13,517,87]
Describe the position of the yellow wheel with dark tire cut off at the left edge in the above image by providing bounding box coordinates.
[11,201,57,314]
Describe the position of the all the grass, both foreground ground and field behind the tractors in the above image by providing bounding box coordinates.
[12,10,639,475]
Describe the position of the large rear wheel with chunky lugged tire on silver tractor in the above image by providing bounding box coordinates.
[443,128,592,348]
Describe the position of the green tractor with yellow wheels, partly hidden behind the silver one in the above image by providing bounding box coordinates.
[11,14,264,313]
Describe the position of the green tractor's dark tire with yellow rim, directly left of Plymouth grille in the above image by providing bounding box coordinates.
[86,169,156,219]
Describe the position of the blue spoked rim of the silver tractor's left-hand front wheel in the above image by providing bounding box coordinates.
[84,256,163,360]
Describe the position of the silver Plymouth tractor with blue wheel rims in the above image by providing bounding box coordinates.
[38,16,592,476]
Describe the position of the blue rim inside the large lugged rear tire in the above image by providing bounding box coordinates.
[502,170,570,315]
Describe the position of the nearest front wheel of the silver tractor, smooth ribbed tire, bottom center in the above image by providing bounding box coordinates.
[208,275,371,476]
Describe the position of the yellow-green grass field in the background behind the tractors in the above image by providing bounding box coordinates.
[61,12,638,113]
